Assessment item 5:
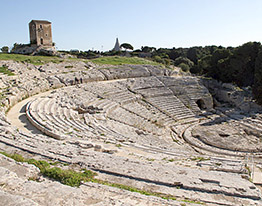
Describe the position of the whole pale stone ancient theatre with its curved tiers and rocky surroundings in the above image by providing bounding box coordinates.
[0,58,262,205]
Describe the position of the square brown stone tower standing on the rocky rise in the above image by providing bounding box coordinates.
[29,20,53,47]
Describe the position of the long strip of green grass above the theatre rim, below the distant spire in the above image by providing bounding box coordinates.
[90,56,161,65]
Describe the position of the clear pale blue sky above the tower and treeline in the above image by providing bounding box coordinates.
[0,0,262,51]
